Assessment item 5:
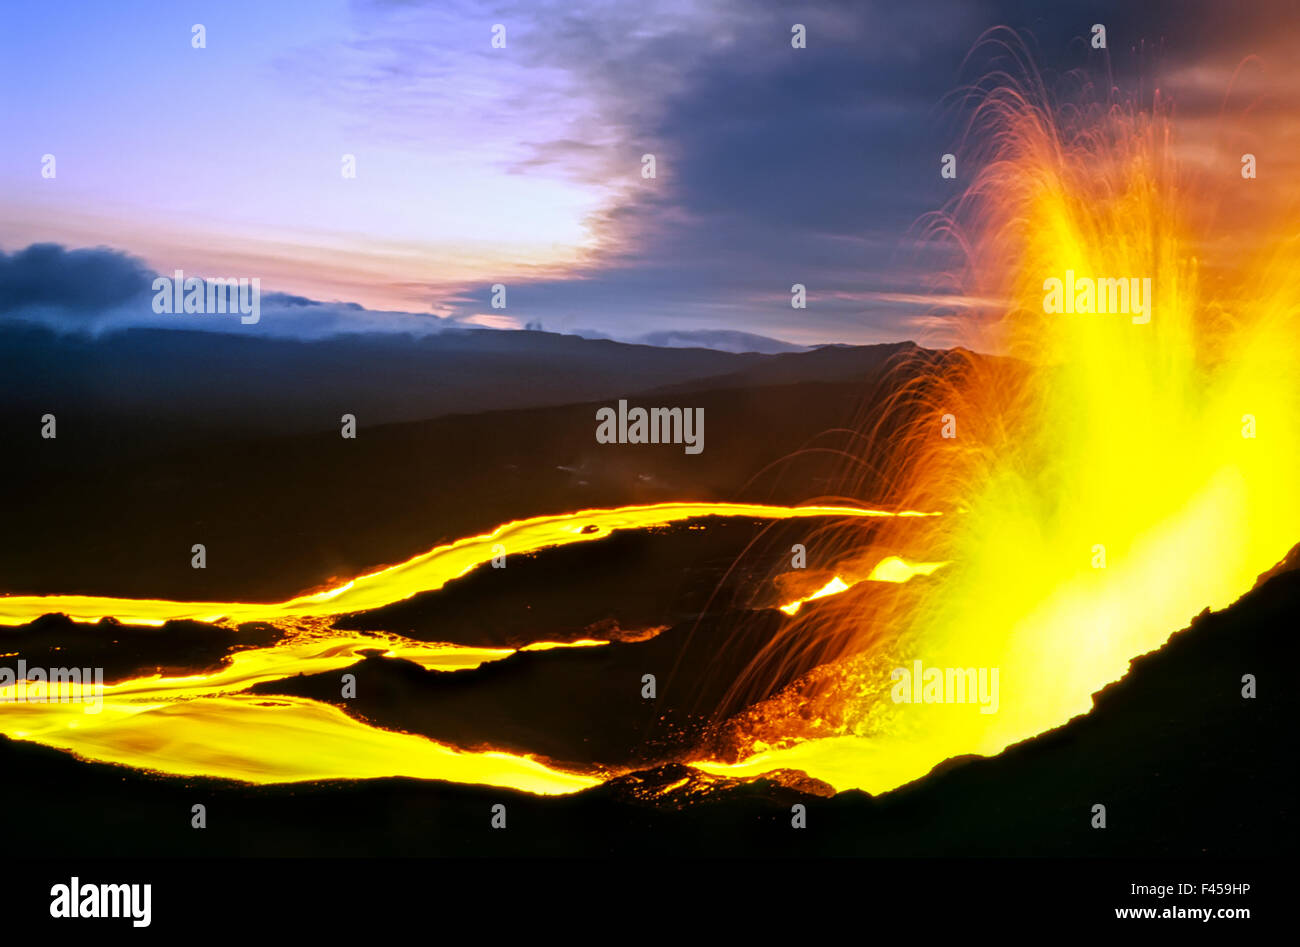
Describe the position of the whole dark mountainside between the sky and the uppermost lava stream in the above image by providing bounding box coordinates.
[0,330,935,600]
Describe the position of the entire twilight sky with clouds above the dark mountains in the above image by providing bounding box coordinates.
[0,0,1300,345]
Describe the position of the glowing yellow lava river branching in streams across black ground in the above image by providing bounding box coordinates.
[0,503,926,795]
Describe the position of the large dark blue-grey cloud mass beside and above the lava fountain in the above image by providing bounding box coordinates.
[434,0,1295,341]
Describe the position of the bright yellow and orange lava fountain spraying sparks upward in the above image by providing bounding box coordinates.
[697,51,1300,792]
